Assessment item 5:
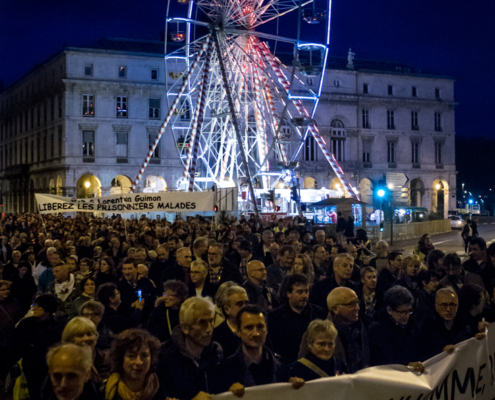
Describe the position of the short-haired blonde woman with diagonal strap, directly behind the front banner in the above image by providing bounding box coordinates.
[289,319,345,382]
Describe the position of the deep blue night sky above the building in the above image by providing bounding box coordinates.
[0,0,495,137]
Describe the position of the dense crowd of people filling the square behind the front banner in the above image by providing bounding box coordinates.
[0,215,495,400]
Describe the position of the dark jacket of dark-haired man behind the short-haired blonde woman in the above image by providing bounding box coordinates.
[268,303,327,362]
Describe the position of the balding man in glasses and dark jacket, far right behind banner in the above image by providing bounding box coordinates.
[416,288,474,360]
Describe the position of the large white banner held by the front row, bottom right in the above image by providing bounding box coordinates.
[213,323,495,400]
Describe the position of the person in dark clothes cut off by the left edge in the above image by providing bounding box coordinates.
[0,280,24,382]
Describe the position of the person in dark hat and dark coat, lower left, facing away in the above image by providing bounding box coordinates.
[12,294,64,400]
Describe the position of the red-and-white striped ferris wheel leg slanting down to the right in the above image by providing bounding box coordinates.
[259,39,359,200]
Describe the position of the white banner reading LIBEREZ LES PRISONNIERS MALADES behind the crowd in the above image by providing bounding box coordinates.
[35,192,215,214]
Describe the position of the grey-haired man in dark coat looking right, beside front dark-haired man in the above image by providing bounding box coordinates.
[158,297,223,400]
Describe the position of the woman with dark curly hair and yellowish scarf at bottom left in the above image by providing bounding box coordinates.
[103,329,163,400]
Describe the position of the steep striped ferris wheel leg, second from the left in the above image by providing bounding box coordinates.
[184,43,213,192]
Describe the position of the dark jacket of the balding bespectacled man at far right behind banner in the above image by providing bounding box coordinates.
[416,313,474,361]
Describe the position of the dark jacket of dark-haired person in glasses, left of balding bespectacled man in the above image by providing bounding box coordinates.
[368,310,418,366]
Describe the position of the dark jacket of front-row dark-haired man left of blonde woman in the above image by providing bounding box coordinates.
[221,346,289,391]
